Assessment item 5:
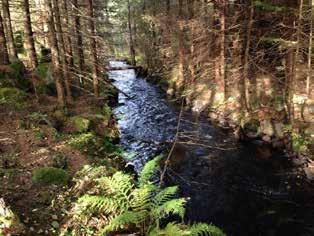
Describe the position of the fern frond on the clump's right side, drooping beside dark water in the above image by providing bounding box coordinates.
[152,198,186,220]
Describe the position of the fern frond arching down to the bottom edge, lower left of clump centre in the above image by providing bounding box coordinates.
[100,211,147,235]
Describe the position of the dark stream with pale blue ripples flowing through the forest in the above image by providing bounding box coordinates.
[109,61,314,236]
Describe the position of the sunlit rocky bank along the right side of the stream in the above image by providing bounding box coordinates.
[137,67,314,162]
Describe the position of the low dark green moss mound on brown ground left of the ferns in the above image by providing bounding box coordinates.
[32,167,70,185]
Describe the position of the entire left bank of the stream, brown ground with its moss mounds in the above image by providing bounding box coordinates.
[0,88,125,235]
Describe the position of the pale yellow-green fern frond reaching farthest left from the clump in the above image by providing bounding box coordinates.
[75,195,122,214]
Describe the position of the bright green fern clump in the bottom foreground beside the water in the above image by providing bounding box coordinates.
[63,157,224,236]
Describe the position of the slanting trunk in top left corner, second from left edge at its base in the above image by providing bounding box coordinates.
[2,0,18,59]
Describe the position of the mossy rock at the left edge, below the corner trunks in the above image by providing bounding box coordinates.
[0,88,27,109]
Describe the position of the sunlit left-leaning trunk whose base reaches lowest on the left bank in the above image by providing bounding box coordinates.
[45,0,65,106]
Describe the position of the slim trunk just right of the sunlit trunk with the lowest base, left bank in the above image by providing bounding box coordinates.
[53,0,73,102]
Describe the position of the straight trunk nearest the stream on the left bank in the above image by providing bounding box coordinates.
[88,0,99,97]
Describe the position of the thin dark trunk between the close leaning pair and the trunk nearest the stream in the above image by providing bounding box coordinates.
[72,0,85,84]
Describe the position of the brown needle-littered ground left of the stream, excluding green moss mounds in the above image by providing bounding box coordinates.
[0,93,121,235]
